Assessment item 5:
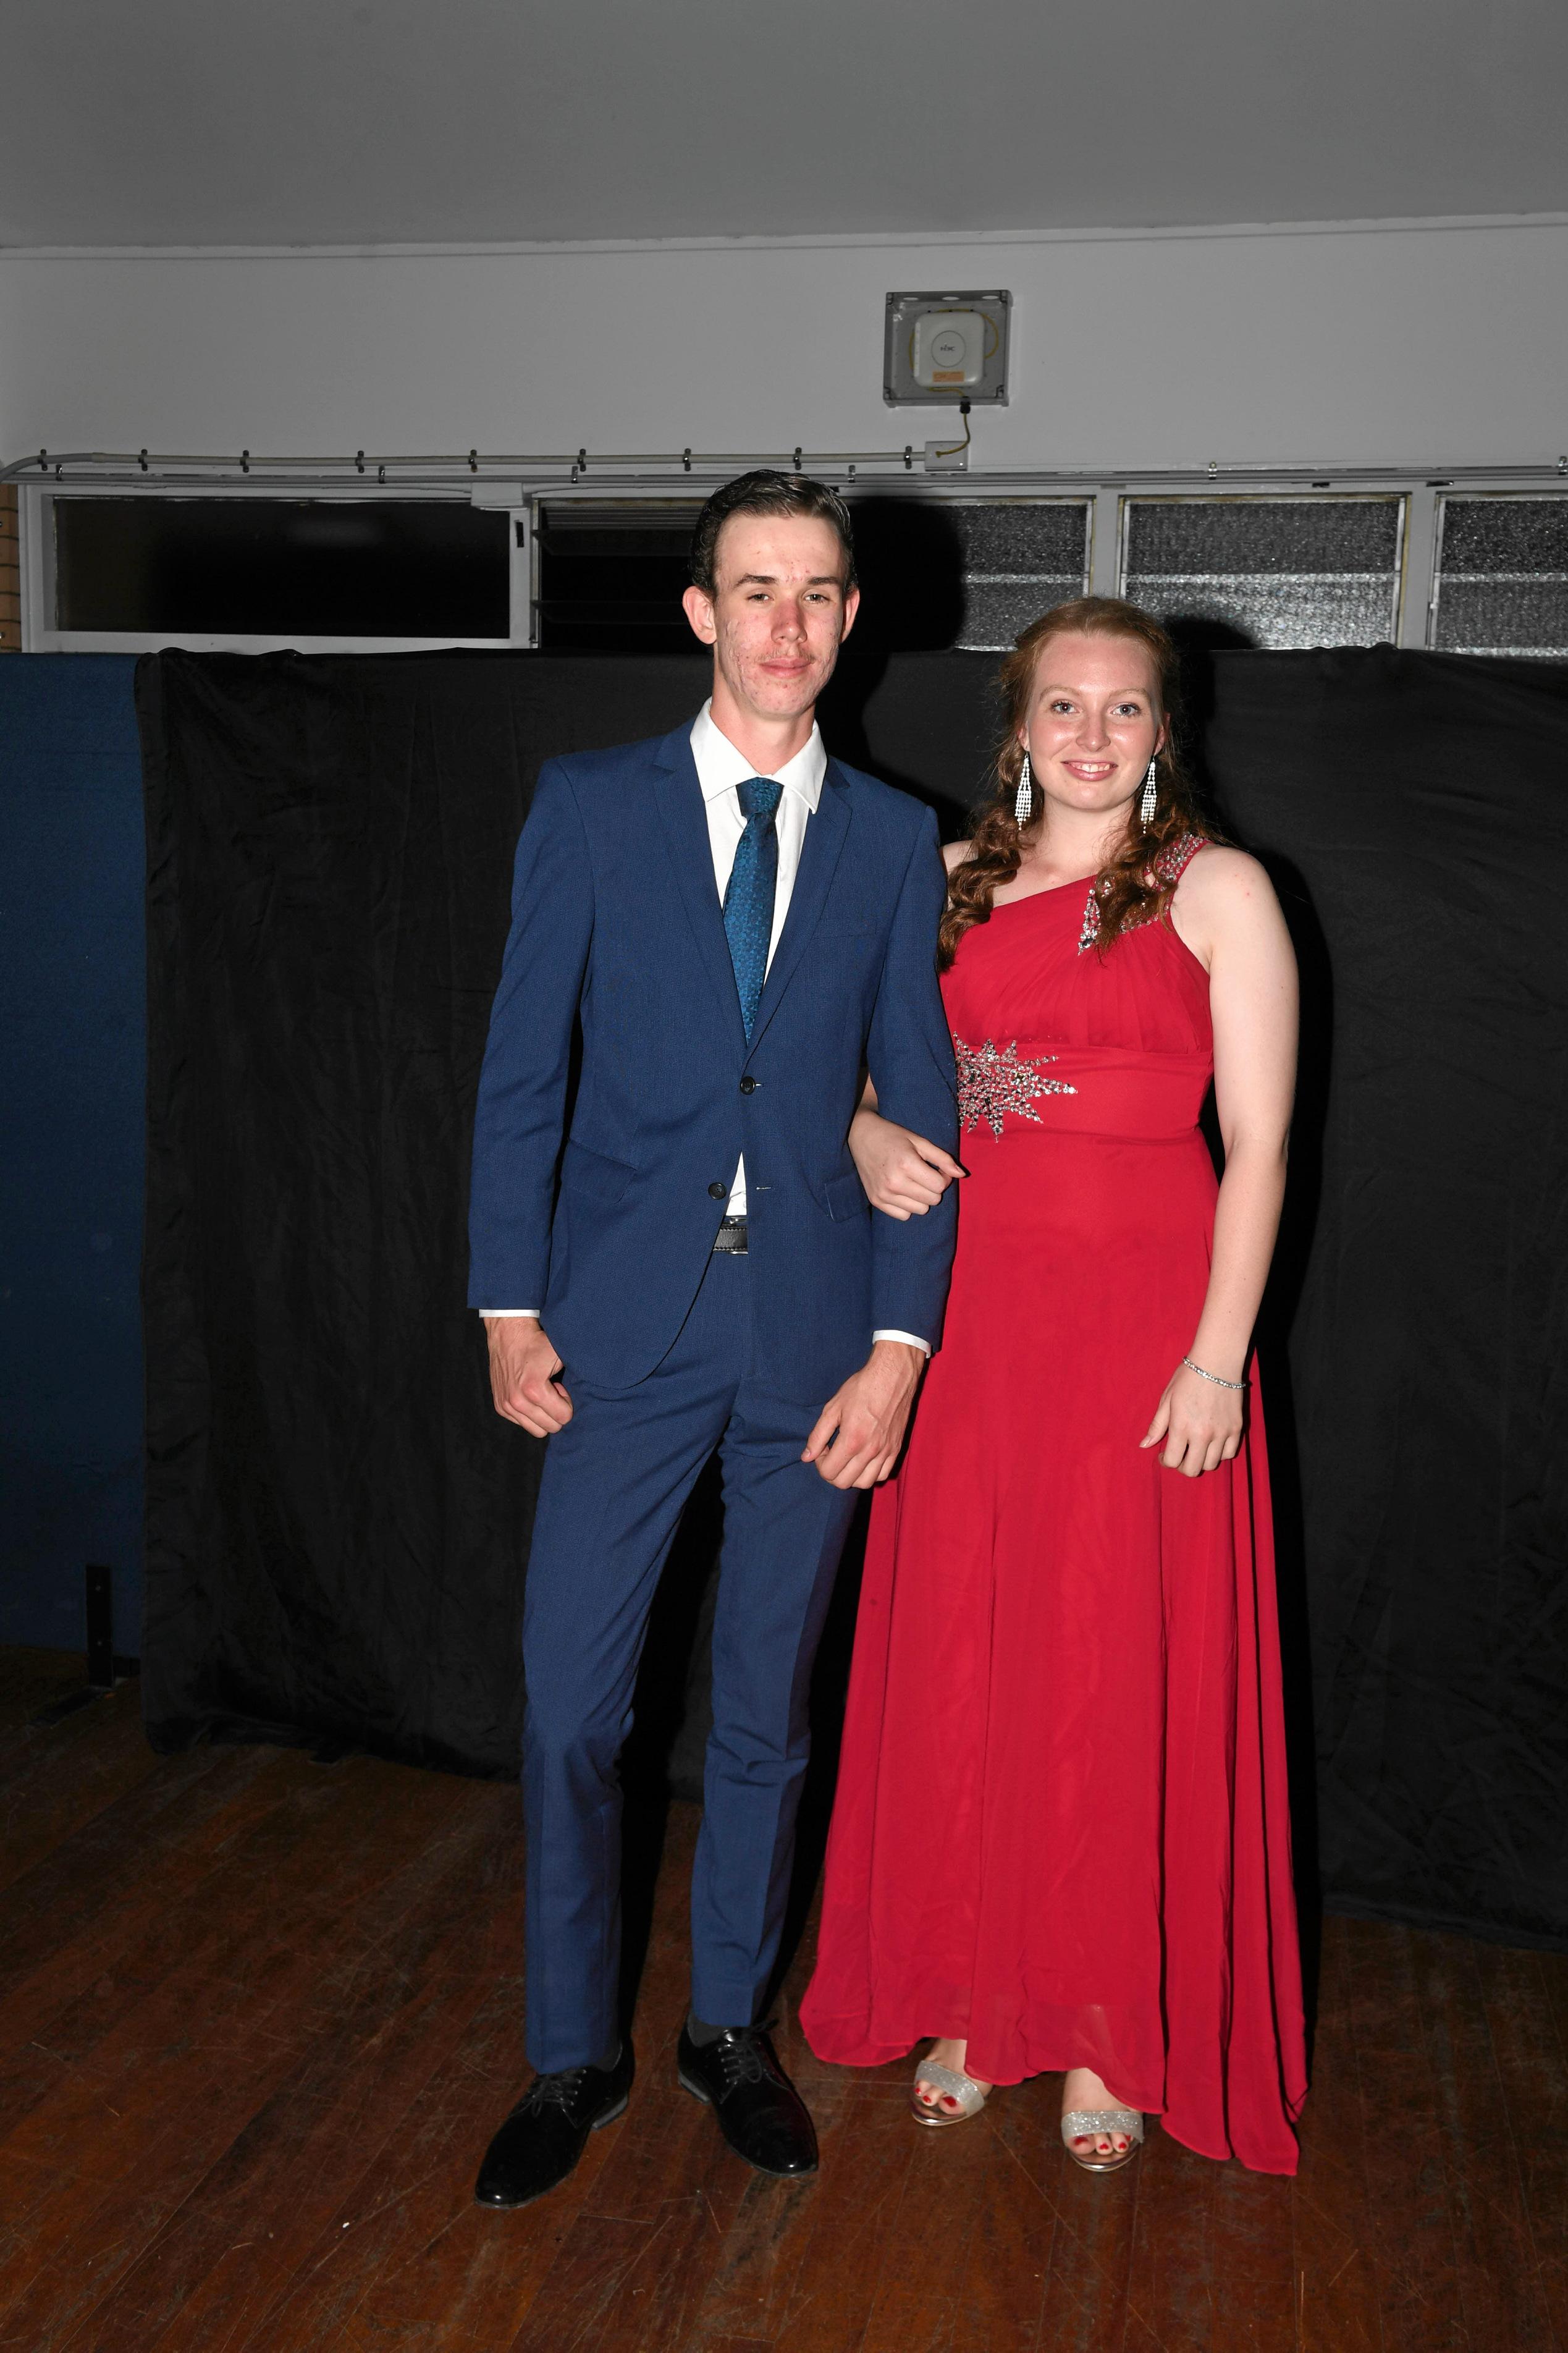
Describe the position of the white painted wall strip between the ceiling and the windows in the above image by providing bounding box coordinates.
[0,221,1568,473]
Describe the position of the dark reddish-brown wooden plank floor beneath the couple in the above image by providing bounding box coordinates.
[0,1652,1568,2353]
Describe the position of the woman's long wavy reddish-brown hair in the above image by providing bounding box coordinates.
[937,595,1220,972]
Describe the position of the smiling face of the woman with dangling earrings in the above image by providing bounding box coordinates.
[1019,635,1165,816]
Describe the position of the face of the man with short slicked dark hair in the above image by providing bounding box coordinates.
[683,515,859,720]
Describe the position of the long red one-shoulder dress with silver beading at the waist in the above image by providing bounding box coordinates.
[801,842,1307,2174]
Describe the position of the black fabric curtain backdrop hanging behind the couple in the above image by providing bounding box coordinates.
[137,647,1568,1943]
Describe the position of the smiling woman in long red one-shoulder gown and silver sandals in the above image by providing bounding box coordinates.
[801,598,1307,2174]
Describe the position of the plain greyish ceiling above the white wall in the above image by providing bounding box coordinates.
[0,0,1568,245]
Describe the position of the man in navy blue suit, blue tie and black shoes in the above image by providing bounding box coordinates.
[468,473,956,2207]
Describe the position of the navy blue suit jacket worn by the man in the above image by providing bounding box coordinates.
[468,727,958,1405]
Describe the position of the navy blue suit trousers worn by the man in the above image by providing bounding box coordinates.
[523,1254,857,2068]
